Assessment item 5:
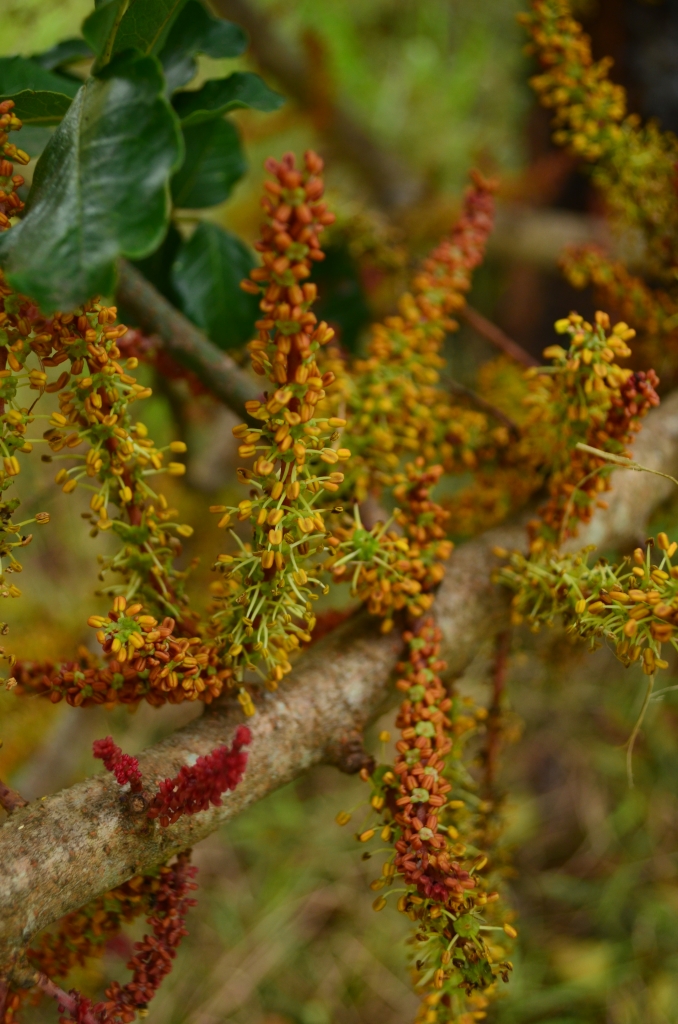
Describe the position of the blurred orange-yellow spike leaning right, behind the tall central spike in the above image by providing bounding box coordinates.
[334,172,508,501]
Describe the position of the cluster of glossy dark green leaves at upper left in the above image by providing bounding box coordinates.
[0,0,284,347]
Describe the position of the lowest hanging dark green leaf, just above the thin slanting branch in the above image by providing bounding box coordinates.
[172,223,258,348]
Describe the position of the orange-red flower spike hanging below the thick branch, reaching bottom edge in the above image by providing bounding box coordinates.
[337,618,516,1024]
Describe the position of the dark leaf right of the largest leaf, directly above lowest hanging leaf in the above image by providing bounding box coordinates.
[172,120,247,210]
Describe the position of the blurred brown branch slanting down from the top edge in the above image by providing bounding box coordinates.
[210,0,424,212]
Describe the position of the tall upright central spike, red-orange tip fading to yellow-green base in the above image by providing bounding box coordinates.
[212,152,350,714]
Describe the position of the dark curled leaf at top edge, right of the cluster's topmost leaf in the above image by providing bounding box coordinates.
[160,0,247,94]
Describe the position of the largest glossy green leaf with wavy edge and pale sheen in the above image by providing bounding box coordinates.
[0,55,181,312]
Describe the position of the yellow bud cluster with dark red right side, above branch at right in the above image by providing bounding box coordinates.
[525,312,659,552]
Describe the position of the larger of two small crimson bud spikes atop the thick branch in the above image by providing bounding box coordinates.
[149,725,252,827]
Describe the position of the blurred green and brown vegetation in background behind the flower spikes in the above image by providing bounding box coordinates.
[6,0,678,1024]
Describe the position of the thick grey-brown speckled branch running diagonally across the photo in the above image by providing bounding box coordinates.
[0,392,678,975]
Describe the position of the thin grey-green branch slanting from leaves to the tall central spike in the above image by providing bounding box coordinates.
[116,260,260,417]
